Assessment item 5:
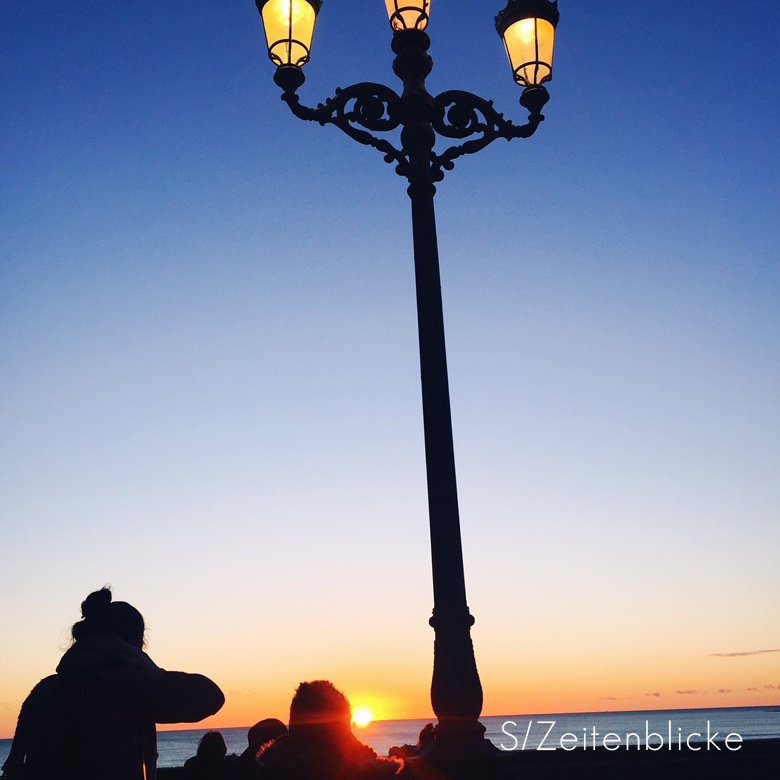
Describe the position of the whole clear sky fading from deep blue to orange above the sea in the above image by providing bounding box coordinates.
[0,0,780,737]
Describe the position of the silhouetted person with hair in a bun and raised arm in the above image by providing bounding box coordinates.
[3,587,225,780]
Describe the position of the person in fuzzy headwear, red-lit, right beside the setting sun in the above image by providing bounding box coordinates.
[258,680,403,780]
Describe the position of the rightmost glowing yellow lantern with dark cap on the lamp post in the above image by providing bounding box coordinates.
[496,0,560,87]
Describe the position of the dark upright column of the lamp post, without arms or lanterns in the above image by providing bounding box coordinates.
[393,30,490,757]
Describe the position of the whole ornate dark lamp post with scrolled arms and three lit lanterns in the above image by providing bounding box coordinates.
[256,0,558,757]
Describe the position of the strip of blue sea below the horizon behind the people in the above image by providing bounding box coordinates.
[0,706,780,767]
